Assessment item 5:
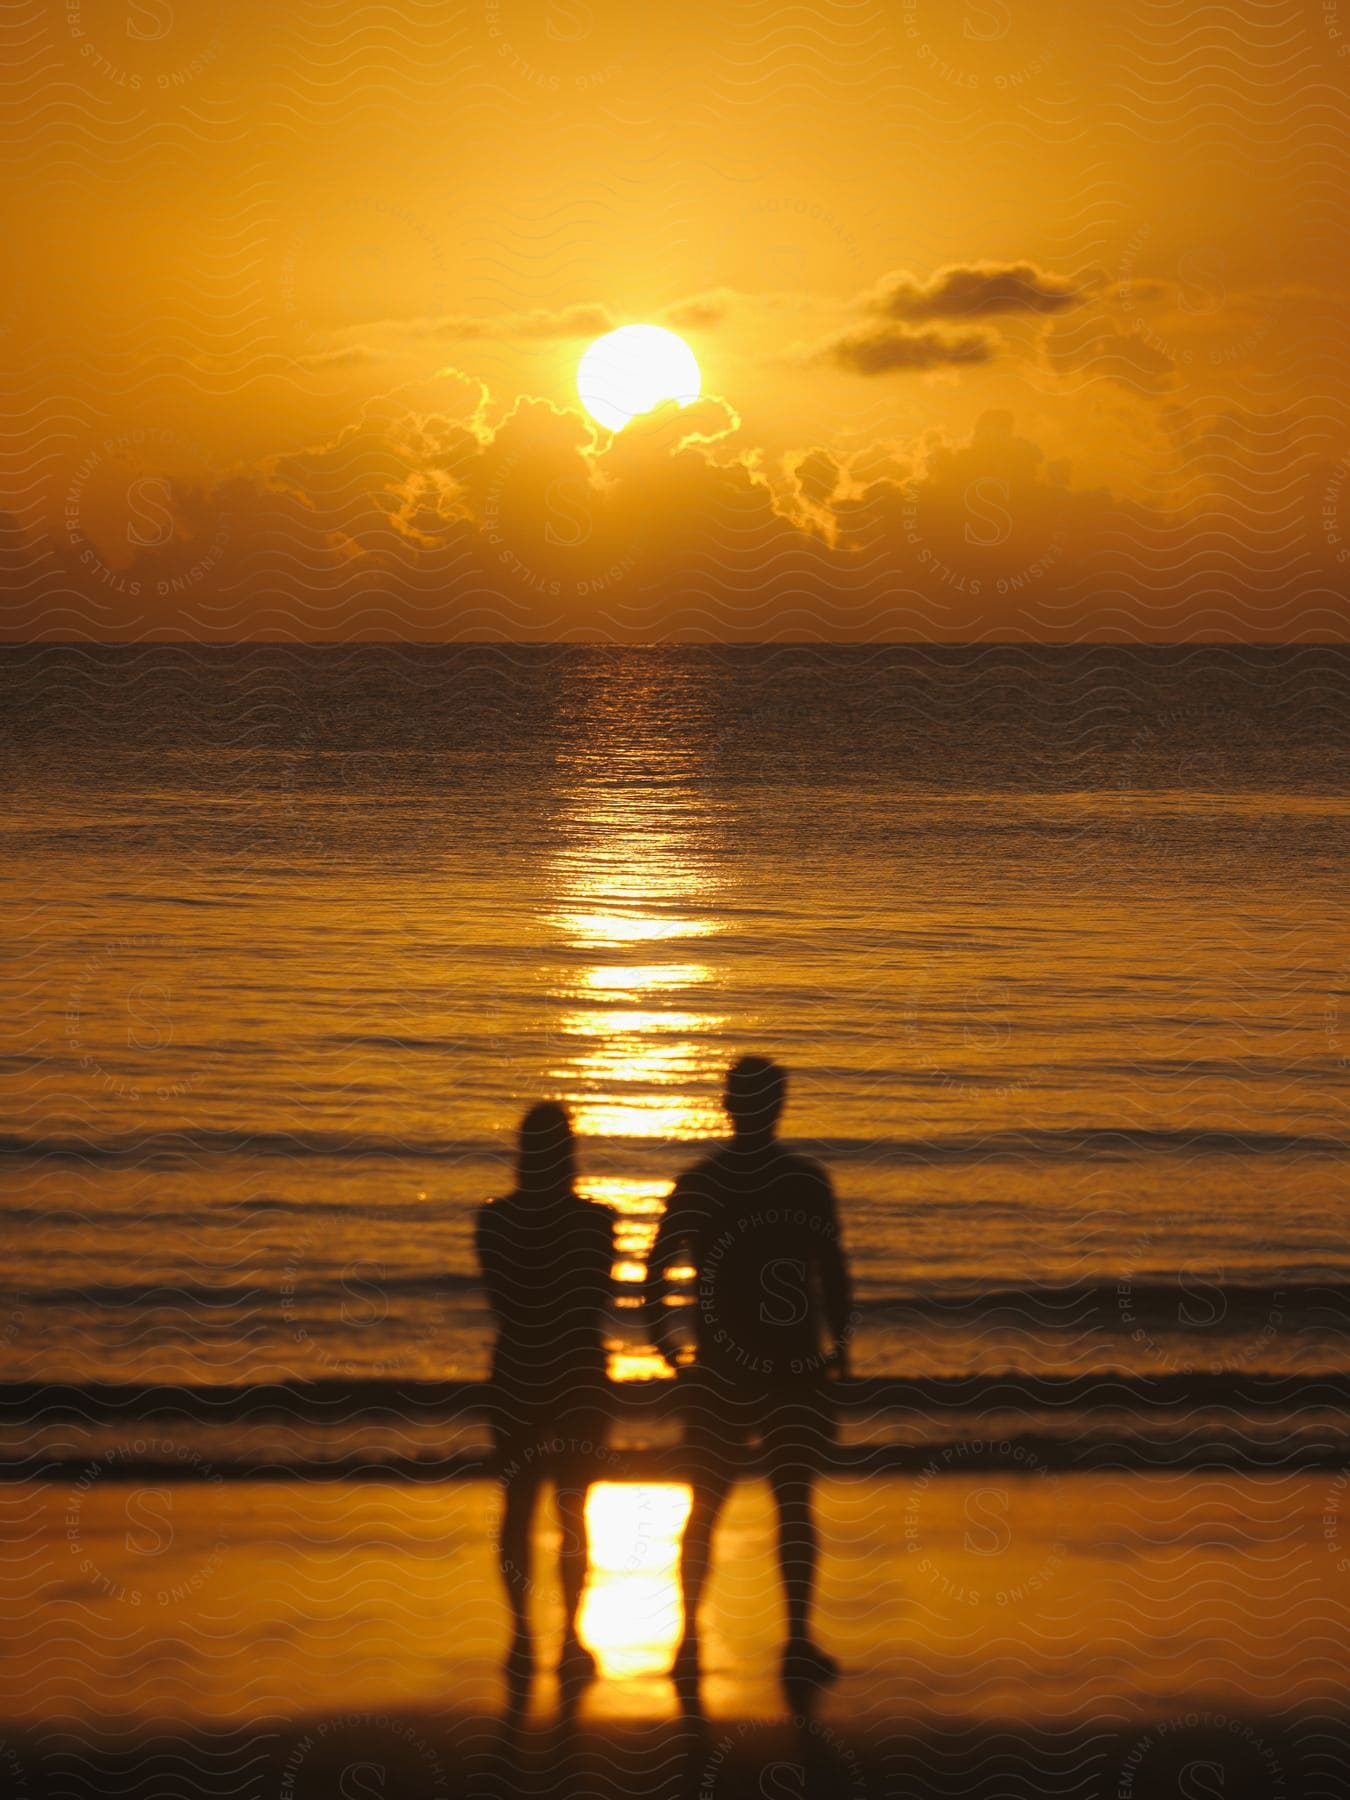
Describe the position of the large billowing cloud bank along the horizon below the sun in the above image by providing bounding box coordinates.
[26,371,1350,643]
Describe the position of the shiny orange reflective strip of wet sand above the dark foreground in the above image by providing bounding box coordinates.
[10,1471,1350,1749]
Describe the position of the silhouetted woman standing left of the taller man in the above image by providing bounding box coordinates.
[475,1102,614,1678]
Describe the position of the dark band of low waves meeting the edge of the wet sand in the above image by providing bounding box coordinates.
[0,1372,1350,1483]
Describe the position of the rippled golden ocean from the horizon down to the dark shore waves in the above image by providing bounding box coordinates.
[0,644,1350,1476]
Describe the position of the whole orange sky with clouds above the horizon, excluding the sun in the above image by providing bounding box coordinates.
[0,0,1350,641]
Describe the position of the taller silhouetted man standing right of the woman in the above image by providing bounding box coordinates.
[646,1057,850,1681]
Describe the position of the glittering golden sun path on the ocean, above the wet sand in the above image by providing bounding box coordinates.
[545,682,731,1381]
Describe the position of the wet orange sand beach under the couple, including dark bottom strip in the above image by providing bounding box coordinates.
[0,1465,1350,1800]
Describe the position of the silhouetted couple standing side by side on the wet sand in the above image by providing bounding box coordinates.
[477,1057,850,1681]
